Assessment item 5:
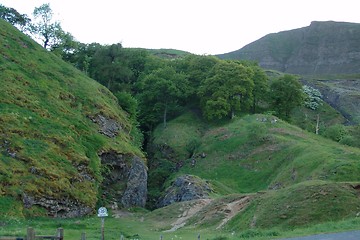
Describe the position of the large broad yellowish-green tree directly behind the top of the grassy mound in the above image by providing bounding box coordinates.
[198,61,254,120]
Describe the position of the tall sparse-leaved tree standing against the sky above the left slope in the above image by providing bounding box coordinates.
[31,3,64,49]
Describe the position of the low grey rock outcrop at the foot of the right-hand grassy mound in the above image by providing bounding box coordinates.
[157,175,212,208]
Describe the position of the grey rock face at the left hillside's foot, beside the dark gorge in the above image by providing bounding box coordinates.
[100,151,147,207]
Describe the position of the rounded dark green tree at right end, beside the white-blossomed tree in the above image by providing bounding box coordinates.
[270,74,304,119]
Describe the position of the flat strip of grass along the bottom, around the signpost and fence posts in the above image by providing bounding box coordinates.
[0,214,360,240]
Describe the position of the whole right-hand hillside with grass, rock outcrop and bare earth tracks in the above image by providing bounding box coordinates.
[149,113,360,230]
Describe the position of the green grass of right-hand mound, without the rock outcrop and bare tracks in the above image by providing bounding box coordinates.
[150,114,360,230]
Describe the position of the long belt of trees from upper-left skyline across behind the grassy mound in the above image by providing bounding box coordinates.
[0,4,304,135]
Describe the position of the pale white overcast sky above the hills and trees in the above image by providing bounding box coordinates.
[0,0,360,54]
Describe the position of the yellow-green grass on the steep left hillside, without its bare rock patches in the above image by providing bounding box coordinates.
[0,20,143,217]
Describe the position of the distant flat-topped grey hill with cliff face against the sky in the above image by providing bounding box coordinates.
[218,21,360,75]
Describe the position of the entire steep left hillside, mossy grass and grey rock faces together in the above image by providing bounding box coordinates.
[0,20,147,217]
